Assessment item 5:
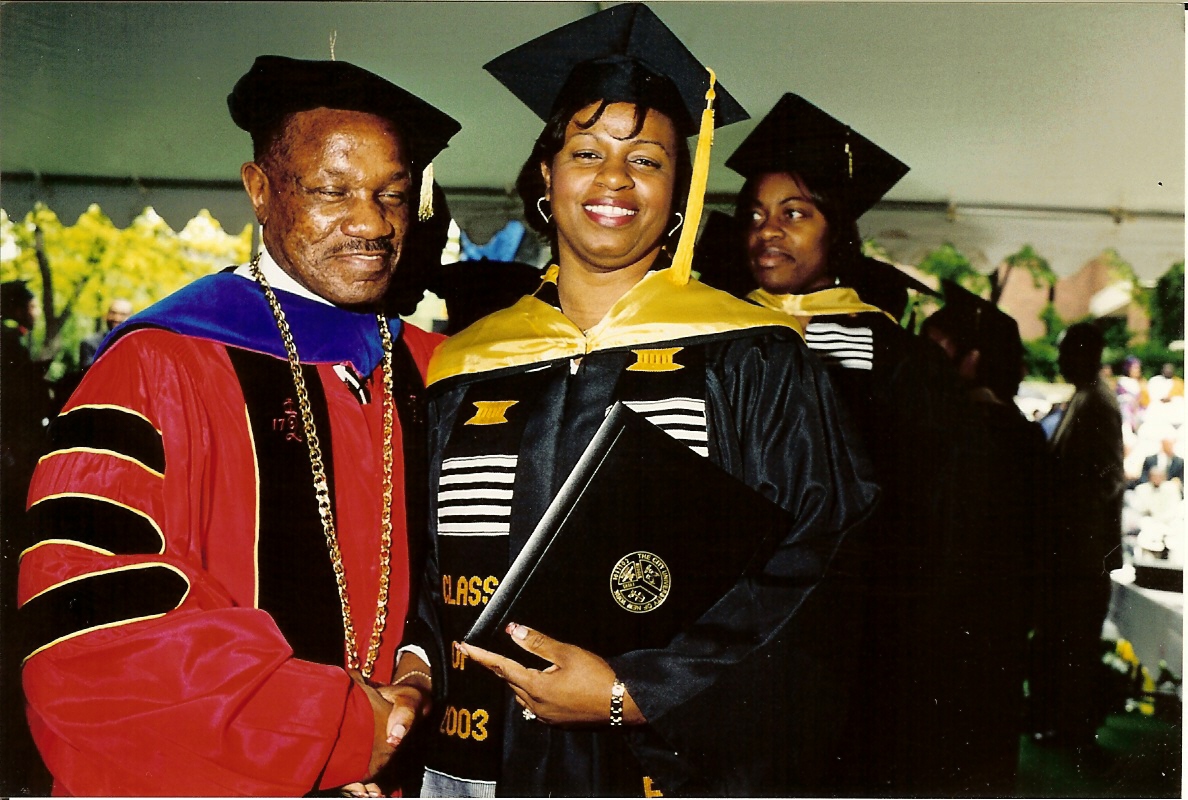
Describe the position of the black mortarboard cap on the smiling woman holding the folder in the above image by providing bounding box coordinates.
[484,2,748,136]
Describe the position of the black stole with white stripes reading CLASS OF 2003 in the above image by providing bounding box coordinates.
[428,346,708,794]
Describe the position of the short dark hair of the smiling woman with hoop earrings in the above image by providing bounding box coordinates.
[516,99,693,259]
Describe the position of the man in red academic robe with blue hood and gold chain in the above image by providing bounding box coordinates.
[19,56,459,795]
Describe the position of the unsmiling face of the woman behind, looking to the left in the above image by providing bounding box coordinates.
[747,172,832,295]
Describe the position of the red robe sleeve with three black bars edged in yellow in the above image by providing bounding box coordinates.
[19,330,401,795]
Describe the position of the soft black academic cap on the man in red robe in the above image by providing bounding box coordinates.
[227,56,462,169]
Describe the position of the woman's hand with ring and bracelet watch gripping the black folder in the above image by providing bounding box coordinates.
[456,623,647,725]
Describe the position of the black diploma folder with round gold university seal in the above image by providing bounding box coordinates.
[463,403,791,661]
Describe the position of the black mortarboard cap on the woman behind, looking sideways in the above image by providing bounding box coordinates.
[726,93,909,219]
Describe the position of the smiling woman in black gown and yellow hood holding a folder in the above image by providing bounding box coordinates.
[377,5,876,796]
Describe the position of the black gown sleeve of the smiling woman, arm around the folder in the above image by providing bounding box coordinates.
[611,335,878,794]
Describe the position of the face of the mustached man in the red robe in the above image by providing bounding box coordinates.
[241,108,412,305]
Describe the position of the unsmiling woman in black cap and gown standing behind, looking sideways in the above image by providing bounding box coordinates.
[726,94,1011,795]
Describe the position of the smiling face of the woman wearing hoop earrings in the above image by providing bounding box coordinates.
[541,103,677,278]
